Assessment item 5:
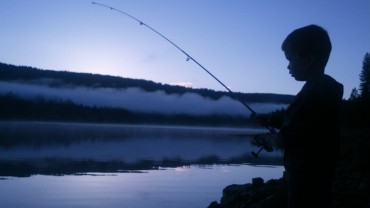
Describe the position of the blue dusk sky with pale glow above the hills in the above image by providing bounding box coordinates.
[0,0,370,98]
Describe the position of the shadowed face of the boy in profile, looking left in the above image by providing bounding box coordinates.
[285,51,311,81]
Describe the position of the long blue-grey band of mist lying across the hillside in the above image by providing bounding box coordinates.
[0,82,285,116]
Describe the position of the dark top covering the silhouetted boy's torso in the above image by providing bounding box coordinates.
[279,74,343,156]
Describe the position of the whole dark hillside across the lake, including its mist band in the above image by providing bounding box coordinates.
[0,63,293,125]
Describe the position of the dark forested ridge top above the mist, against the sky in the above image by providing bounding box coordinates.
[0,63,293,104]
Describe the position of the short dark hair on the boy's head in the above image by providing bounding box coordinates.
[281,25,331,70]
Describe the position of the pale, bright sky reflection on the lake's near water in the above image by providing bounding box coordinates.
[0,165,282,208]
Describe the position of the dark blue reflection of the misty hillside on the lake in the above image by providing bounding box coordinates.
[0,122,281,177]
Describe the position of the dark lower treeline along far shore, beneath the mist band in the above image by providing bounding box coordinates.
[0,93,253,126]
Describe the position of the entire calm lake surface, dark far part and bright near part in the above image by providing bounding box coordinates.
[0,122,283,208]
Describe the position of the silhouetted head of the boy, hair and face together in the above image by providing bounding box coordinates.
[282,25,331,81]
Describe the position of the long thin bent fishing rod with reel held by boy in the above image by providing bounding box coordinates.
[92,2,277,157]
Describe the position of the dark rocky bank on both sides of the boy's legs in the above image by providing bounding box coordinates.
[208,129,370,208]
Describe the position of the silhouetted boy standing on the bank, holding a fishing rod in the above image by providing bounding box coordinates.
[278,25,343,208]
